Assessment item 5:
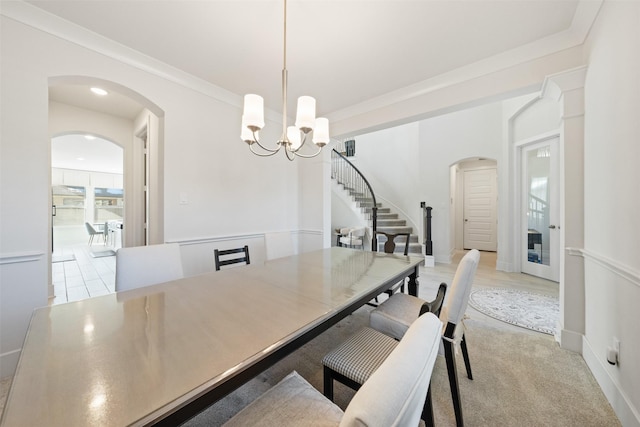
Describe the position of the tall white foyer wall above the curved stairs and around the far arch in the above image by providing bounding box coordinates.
[353,102,505,263]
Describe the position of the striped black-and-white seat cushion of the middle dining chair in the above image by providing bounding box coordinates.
[322,327,398,384]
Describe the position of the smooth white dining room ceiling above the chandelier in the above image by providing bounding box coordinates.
[28,0,579,115]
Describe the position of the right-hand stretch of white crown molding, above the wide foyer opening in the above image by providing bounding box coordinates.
[327,0,604,122]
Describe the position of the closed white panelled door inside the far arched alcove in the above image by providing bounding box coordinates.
[464,168,498,252]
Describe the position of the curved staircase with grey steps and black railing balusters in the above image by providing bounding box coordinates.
[331,150,422,255]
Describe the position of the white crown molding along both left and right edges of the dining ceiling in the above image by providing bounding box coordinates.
[0,0,603,127]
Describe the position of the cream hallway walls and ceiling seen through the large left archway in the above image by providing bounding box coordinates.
[49,76,164,302]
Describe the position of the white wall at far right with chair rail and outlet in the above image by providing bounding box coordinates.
[583,1,640,426]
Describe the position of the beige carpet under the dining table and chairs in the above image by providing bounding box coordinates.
[185,308,620,427]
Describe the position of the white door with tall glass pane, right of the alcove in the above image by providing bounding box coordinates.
[521,137,560,282]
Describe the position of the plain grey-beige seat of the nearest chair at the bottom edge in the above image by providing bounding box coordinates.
[224,371,343,427]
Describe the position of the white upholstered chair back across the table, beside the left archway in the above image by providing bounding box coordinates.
[116,243,184,292]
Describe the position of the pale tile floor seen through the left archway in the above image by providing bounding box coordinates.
[49,243,116,305]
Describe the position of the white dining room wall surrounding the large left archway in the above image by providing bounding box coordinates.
[0,15,308,377]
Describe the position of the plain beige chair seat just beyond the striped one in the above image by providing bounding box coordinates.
[369,293,425,340]
